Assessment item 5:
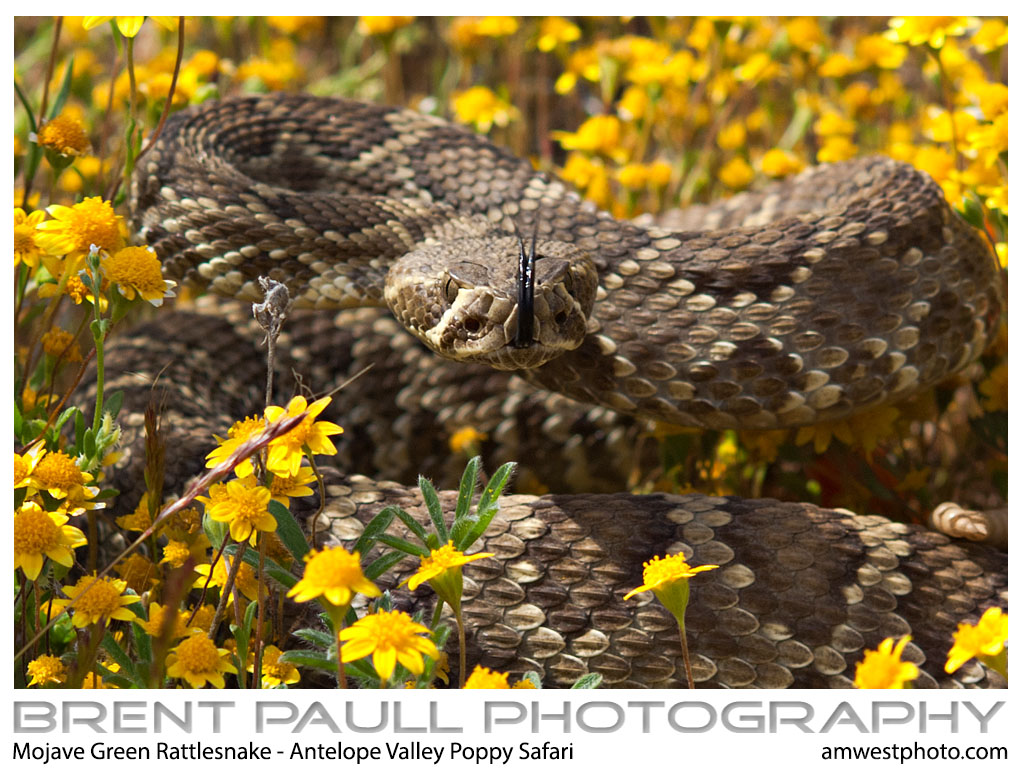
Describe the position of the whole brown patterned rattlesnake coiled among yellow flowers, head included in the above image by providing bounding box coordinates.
[97,94,1007,687]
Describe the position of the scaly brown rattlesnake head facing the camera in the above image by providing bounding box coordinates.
[384,237,597,371]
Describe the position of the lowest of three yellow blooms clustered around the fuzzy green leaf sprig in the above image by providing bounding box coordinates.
[338,610,438,680]
